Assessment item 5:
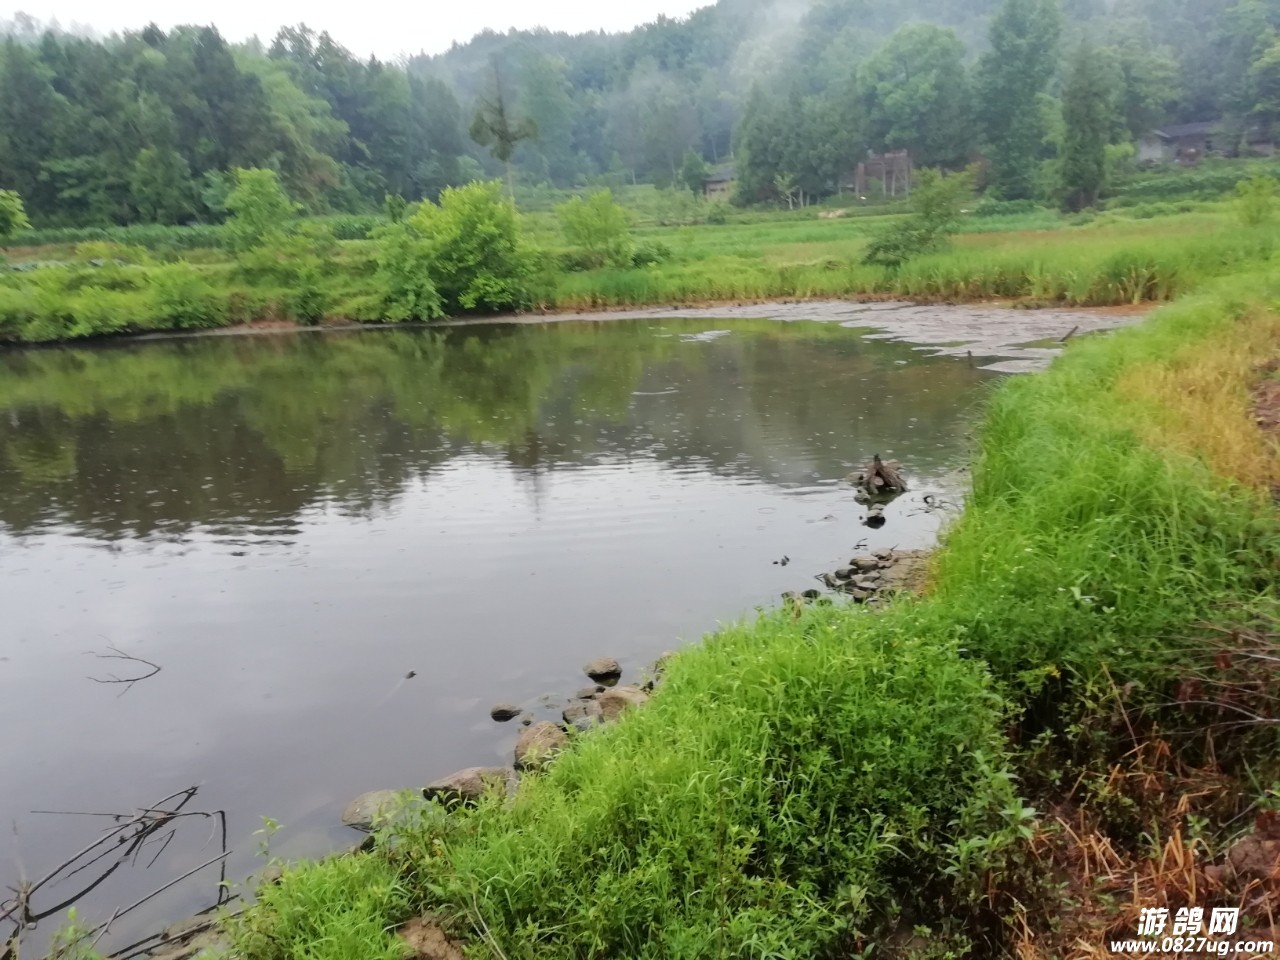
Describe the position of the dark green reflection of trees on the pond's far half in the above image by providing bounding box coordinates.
[0,320,983,536]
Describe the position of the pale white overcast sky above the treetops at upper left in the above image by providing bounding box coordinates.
[15,0,712,59]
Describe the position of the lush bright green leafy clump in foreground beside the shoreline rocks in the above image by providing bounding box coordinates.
[241,607,1024,960]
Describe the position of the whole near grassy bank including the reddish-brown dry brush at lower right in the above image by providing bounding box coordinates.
[225,272,1280,960]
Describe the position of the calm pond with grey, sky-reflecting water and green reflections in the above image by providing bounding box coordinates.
[0,309,1100,957]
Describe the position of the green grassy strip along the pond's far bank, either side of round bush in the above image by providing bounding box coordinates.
[0,195,1275,343]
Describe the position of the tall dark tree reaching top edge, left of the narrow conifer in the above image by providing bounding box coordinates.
[978,0,1062,200]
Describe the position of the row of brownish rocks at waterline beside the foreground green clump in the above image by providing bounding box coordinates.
[342,653,671,831]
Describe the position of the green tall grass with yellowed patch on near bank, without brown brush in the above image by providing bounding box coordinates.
[227,273,1280,960]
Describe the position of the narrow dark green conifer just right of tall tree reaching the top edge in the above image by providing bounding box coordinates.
[1061,42,1112,210]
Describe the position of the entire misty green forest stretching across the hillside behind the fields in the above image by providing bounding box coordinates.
[0,0,1280,227]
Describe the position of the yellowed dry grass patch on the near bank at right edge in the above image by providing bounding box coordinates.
[1116,311,1280,490]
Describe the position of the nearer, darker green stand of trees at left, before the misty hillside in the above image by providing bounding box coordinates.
[0,26,481,225]
